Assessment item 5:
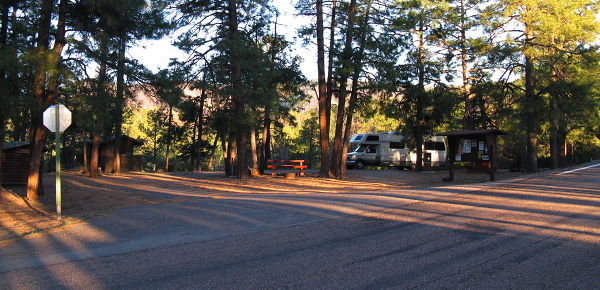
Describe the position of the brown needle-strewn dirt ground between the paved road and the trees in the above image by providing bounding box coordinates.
[0,170,524,247]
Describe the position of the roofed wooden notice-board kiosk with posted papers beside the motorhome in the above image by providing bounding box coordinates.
[436,129,508,181]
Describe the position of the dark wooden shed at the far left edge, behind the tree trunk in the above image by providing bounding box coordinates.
[0,141,31,185]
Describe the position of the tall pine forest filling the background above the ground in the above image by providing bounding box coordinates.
[0,0,600,199]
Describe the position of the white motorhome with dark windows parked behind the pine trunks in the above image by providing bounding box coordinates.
[346,132,447,169]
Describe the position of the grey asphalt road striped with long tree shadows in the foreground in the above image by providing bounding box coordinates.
[0,166,600,289]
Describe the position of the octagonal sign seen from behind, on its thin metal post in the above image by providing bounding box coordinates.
[43,104,71,220]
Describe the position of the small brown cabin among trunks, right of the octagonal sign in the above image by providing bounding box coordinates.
[78,135,144,172]
